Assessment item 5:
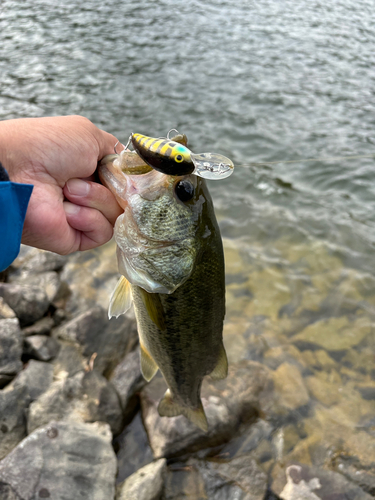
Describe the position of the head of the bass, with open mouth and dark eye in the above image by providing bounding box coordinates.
[99,155,212,293]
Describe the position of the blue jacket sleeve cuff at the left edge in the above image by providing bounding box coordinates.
[0,163,33,271]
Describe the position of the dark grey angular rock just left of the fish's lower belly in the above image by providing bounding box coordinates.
[53,307,138,374]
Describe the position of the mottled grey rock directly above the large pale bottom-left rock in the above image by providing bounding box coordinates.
[27,371,123,434]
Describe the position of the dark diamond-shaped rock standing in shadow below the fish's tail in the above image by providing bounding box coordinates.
[114,412,154,482]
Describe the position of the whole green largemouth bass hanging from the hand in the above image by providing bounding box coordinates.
[98,137,228,431]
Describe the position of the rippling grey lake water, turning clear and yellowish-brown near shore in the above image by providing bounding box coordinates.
[0,0,375,496]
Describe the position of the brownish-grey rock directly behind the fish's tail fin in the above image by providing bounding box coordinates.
[141,360,272,458]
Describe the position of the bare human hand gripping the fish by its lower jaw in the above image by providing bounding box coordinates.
[0,116,122,254]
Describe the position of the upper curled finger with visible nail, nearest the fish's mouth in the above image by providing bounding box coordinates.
[64,179,123,225]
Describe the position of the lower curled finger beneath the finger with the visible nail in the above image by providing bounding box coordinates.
[64,201,113,251]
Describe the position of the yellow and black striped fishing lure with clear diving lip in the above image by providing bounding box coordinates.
[130,133,234,179]
